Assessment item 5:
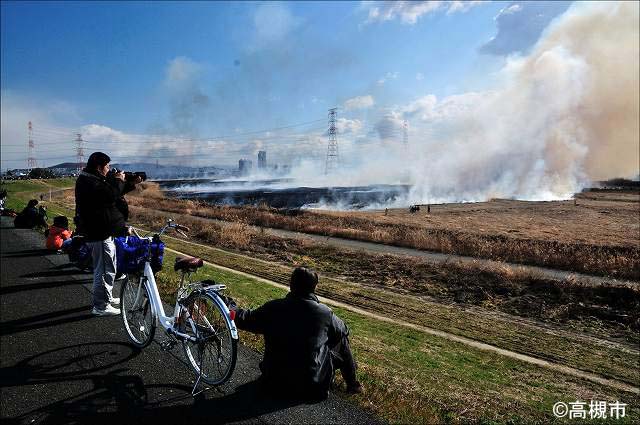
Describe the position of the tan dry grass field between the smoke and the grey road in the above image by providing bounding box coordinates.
[130,191,640,280]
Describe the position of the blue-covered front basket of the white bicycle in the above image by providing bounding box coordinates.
[114,236,164,273]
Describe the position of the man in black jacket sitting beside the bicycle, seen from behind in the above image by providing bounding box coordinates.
[230,267,362,400]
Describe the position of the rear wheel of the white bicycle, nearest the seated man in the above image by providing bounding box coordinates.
[180,294,238,385]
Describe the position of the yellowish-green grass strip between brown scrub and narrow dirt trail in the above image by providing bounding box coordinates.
[154,234,640,386]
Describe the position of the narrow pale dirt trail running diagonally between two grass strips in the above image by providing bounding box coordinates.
[165,242,640,395]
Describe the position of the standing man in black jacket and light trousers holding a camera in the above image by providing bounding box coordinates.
[75,152,142,316]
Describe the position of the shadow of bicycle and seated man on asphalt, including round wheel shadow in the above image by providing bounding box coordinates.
[0,342,304,424]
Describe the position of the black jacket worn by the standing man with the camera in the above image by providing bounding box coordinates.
[76,170,126,241]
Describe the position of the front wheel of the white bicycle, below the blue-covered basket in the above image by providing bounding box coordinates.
[120,275,156,348]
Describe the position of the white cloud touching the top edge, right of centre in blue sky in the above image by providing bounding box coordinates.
[363,1,483,25]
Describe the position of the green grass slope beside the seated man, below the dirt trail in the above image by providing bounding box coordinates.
[158,250,640,423]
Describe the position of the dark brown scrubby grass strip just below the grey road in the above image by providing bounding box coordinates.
[132,207,640,343]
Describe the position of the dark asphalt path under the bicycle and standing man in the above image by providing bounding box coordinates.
[0,217,379,424]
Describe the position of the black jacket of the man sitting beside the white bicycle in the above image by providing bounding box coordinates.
[235,292,349,398]
